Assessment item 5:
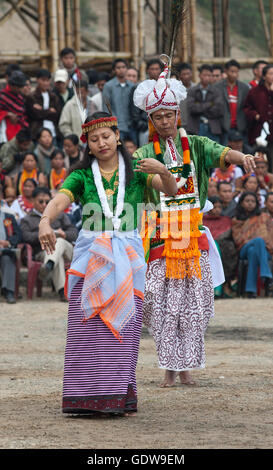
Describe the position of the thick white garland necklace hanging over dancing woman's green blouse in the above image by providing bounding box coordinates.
[91,152,125,230]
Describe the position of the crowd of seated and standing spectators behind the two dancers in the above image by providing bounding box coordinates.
[0,48,273,303]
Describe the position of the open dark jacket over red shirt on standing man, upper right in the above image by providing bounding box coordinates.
[214,79,249,132]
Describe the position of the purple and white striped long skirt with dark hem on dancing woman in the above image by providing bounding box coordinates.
[63,279,142,414]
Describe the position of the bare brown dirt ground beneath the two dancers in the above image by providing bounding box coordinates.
[0,293,273,449]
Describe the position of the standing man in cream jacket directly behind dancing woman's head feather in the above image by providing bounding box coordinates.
[59,80,94,137]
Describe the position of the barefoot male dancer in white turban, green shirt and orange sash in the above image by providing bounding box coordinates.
[134,59,255,387]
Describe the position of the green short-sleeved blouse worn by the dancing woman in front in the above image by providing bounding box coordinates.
[59,158,151,231]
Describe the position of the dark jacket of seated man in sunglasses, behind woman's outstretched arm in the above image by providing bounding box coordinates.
[20,211,78,256]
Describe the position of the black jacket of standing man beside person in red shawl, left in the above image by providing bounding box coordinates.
[26,88,61,139]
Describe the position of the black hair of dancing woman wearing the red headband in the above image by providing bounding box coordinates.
[69,111,134,186]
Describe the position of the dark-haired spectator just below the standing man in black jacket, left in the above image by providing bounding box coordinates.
[34,127,55,175]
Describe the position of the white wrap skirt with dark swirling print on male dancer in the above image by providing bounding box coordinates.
[143,251,214,371]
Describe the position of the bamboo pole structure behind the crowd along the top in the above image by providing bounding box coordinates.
[0,0,273,80]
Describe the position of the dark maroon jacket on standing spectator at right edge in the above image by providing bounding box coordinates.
[244,85,273,145]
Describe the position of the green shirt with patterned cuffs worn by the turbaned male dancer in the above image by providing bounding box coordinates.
[134,132,230,209]
